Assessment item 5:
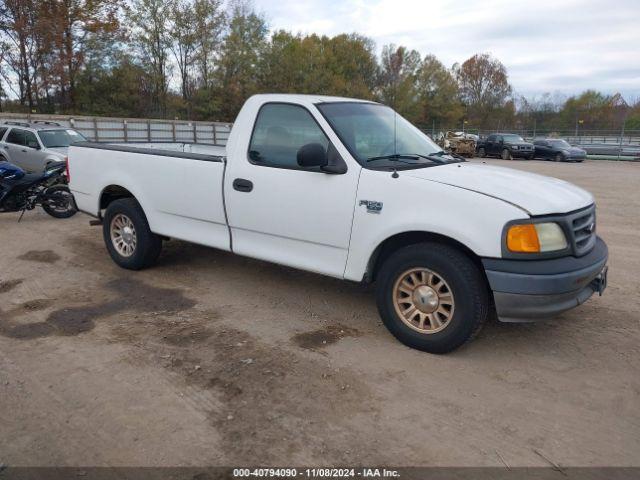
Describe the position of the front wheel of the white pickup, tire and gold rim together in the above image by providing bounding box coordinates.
[376,243,489,353]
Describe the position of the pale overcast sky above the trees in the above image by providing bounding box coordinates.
[254,0,640,99]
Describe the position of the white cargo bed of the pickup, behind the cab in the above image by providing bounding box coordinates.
[69,142,230,250]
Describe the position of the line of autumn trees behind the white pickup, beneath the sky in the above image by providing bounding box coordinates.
[0,0,640,131]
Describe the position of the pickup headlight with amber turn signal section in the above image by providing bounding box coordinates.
[507,222,568,253]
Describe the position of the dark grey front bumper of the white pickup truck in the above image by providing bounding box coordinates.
[482,237,609,322]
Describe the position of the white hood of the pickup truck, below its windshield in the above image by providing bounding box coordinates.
[408,163,593,215]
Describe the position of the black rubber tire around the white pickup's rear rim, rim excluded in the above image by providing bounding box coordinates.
[102,198,162,270]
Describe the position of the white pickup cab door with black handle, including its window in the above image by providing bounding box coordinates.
[225,103,360,278]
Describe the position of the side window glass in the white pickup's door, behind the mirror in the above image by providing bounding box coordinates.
[249,103,329,170]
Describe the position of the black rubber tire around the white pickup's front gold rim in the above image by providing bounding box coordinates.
[376,242,489,353]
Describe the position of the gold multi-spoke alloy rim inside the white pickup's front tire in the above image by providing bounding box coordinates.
[393,268,455,333]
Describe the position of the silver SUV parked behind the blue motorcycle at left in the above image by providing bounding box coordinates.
[0,121,86,173]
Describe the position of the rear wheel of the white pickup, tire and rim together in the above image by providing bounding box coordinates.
[102,198,162,270]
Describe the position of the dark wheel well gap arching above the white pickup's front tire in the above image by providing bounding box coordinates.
[365,232,484,282]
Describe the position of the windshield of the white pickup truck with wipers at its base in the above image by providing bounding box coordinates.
[317,102,458,169]
